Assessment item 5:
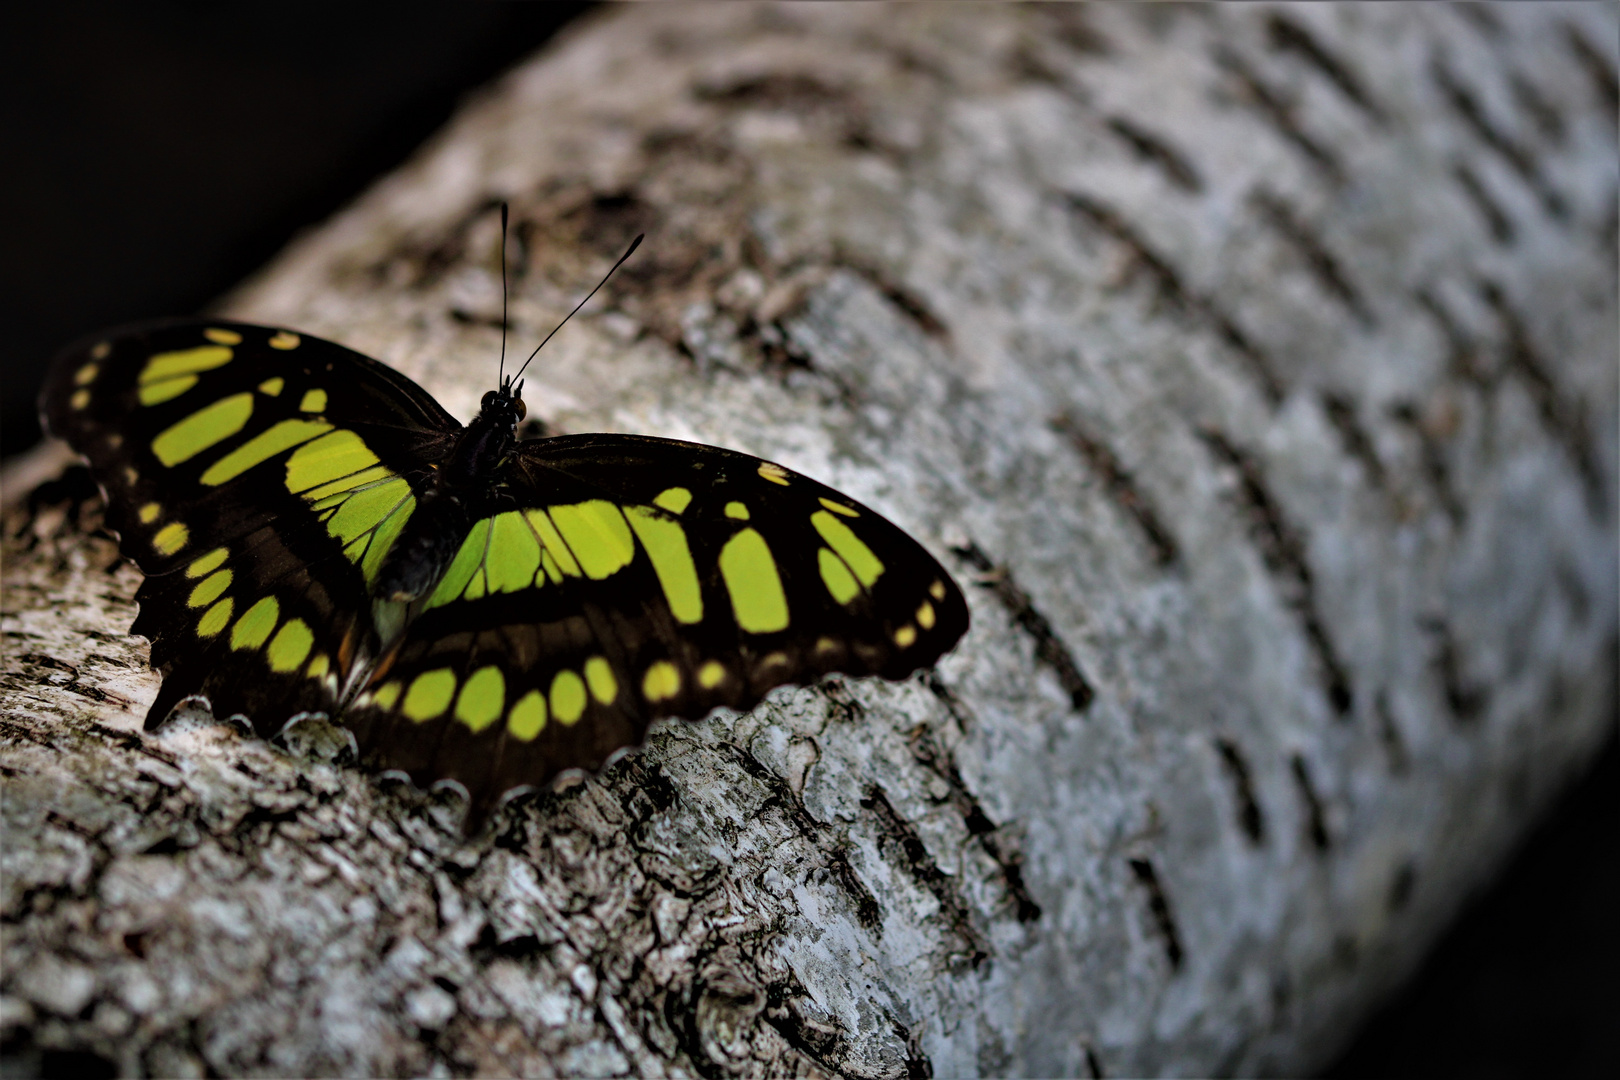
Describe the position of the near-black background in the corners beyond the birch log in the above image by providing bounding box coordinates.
[0,2,1620,1077]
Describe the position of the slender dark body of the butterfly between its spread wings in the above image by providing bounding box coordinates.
[373,384,525,604]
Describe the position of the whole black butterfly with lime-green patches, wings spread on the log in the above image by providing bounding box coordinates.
[41,234,967,826]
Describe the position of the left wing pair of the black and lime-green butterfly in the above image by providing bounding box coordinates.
[41,321,460,733]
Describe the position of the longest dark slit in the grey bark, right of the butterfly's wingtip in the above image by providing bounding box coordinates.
[1200,429,1354,717]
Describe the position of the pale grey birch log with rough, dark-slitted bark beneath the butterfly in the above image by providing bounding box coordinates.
[0,5,1617,1077]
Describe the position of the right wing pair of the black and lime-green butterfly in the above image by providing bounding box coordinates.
[347,434,967,818]
